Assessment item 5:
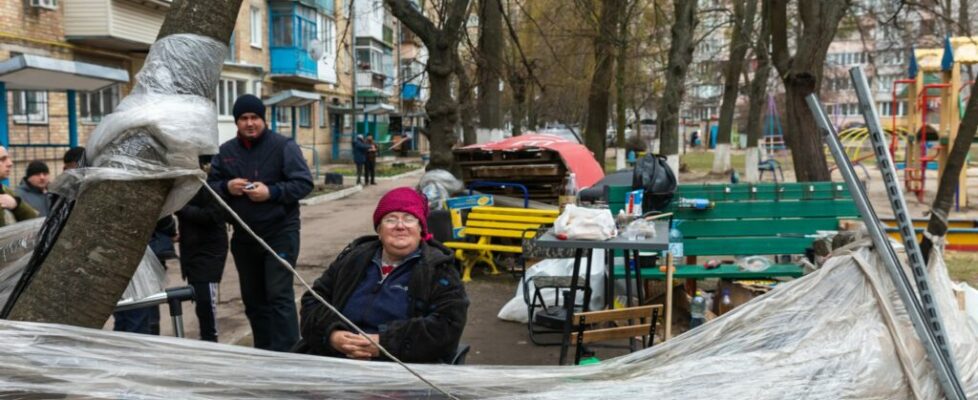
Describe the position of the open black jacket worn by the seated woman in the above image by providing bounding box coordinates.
[295,236,469,363]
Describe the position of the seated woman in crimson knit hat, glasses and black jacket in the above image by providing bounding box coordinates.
[296,187,469,363]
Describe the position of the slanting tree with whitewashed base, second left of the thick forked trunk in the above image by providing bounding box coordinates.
[713,0,757,174]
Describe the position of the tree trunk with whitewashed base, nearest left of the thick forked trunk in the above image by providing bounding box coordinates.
[744,1,771,182]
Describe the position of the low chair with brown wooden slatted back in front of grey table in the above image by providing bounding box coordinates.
[570,304,663,365]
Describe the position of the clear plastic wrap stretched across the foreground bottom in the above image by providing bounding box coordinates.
[0,238,978,400]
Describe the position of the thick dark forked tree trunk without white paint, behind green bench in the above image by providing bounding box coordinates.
[769,0,850,182]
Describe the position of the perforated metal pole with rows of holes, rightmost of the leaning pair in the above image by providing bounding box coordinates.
[849,67,964,397]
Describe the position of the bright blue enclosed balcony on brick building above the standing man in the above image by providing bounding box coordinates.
[269,1,319,84]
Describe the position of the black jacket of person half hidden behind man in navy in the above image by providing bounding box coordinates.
[176,188,228,282]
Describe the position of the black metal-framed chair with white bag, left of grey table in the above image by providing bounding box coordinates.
[520,227,591,346]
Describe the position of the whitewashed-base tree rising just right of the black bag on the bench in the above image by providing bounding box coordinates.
[656,0,698,171]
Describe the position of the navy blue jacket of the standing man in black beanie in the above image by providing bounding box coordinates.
[207,129,312,239]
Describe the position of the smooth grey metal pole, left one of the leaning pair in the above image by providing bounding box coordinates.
[805,94,967,399]
